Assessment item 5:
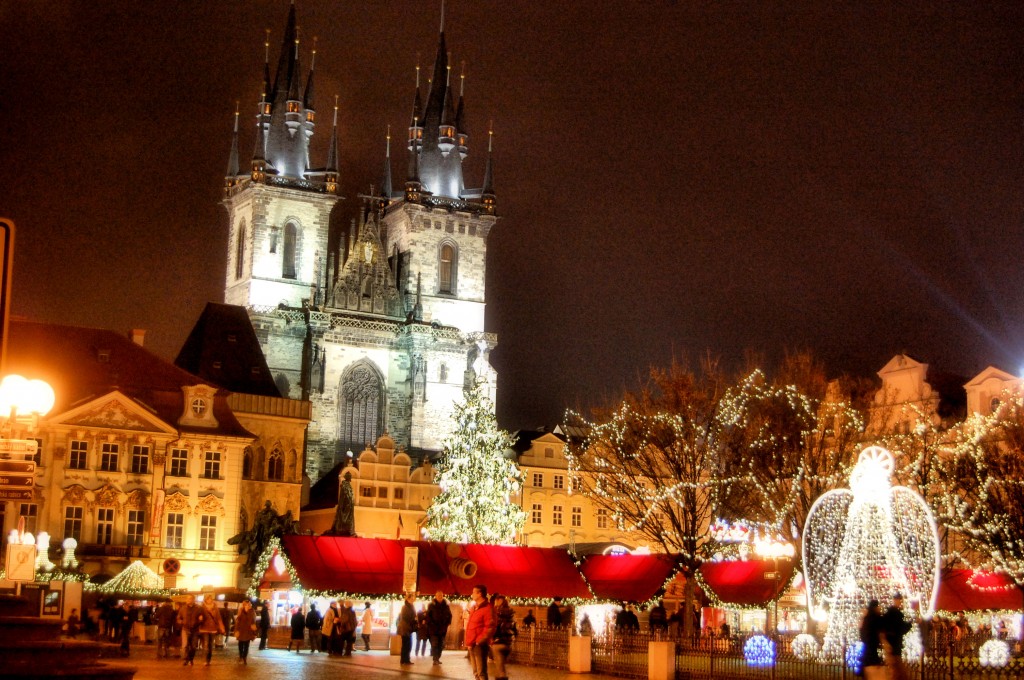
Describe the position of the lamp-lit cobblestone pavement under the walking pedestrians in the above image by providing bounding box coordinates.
[105,645,611,680]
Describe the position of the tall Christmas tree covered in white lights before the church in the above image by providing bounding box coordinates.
[427,383,526,544]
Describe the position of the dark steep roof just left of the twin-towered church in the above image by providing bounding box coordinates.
[174,302,282,396]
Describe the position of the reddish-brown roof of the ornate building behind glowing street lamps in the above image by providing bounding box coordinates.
[6,320,253,437]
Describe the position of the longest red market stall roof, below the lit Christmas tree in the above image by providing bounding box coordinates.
[272,536,591,599]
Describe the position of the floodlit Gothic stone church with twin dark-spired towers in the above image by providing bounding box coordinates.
[223,4,497,481]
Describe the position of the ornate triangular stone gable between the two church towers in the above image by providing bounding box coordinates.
[328,209,404,317]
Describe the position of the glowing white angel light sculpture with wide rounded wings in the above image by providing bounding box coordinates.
[804,447,939,658]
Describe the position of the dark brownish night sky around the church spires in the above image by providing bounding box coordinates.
[0,0,1024,429]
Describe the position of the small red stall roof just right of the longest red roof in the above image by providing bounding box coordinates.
[581,554,676,602]
